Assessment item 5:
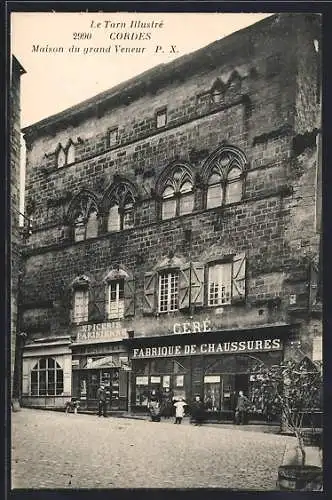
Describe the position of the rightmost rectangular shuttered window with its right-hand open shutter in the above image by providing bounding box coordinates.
[207,253,246,306]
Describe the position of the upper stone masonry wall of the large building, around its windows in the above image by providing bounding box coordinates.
[22,14,318,356]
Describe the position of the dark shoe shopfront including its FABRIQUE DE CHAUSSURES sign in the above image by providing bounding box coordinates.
[131,331,284,419]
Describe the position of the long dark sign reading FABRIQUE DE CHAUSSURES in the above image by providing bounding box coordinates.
[132,339,282,359]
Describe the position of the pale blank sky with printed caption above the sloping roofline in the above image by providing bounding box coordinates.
[10,12,272,218]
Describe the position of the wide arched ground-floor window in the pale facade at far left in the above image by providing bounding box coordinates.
[30,358,63,396]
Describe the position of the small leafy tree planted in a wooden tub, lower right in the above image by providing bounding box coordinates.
[250,356,322,490]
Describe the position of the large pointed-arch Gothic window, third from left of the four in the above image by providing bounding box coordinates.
[161,166,194,220]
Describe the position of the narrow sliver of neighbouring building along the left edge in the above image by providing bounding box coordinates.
[9,56,25,406]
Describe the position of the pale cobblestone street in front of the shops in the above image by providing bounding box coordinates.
[12,409,293,490]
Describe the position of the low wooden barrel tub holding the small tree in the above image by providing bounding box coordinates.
[277,465,323,491]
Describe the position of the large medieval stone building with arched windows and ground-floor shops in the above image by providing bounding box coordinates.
[22,13,322,416]
